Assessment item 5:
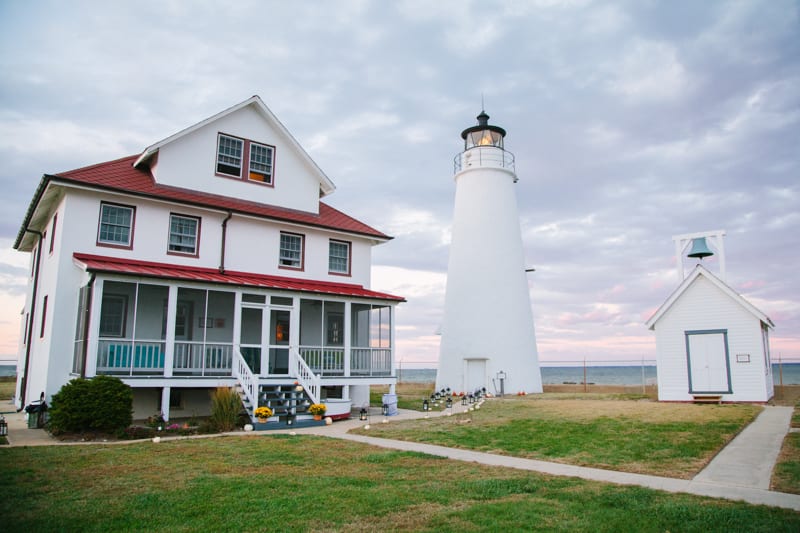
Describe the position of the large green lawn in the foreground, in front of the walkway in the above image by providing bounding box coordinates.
[0,435,800,532]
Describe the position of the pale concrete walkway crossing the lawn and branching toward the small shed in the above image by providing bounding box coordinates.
[6,404,800,511]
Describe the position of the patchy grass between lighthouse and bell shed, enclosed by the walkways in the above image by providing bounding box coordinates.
[356,395,762,479]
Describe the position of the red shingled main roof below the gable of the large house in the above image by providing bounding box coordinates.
[50,155,391,239]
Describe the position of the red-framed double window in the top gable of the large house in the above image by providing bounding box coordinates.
[217,133,275,185]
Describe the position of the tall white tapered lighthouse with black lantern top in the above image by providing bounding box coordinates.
[436,111,542,394]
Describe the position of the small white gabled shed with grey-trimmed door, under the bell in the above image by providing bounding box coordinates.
[646,265,775,402]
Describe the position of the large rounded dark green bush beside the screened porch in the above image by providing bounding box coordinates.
[49,376,133,434]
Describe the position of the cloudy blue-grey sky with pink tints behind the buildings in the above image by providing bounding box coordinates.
[0,0,800,368]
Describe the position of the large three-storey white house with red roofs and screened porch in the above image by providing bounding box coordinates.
[9,96,403,419]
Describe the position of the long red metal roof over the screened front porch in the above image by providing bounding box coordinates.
[73,253,406,302]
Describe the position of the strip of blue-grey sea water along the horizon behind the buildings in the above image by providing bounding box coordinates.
[397,363,800,387]
